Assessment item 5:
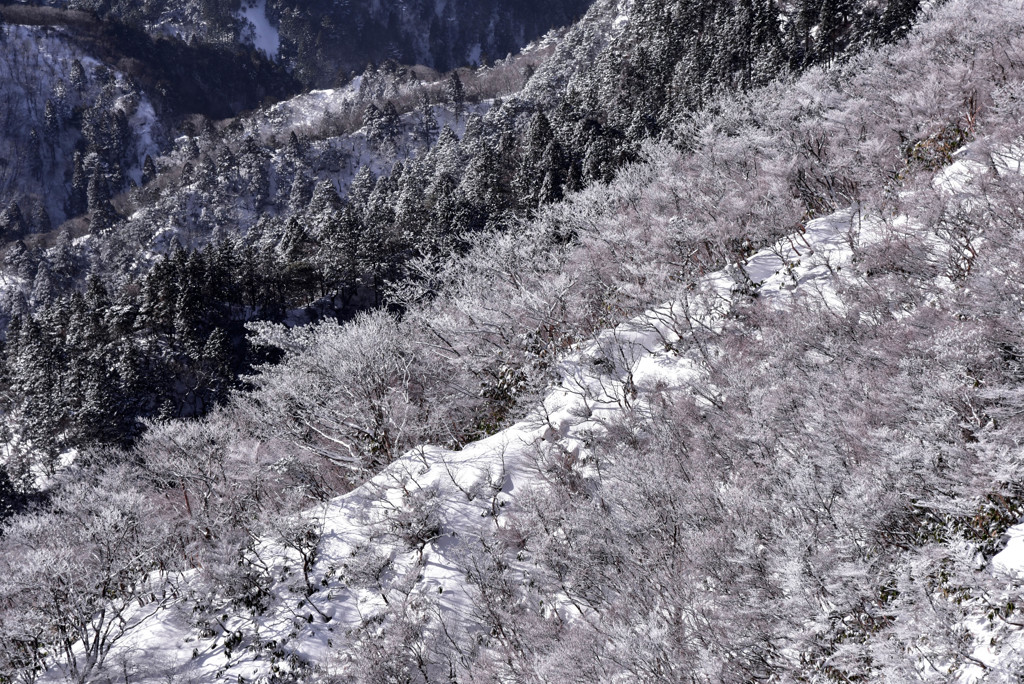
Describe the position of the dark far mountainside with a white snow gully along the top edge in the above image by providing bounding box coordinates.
[37,0,590,87]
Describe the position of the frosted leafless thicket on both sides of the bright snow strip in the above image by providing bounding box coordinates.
[8,3,1024,681]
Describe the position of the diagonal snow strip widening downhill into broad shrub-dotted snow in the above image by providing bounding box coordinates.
[77,189,905,681]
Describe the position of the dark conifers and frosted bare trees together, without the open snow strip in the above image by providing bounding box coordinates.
[6,0,1024,682]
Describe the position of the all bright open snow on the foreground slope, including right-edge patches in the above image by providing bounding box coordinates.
[72,122,1024,682]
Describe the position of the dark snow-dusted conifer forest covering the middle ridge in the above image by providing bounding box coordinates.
[5,3,916,475]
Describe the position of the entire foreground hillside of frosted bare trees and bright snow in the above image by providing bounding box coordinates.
[0,1,1024,682]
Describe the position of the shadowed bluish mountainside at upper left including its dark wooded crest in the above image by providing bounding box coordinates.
[0,7,295,244]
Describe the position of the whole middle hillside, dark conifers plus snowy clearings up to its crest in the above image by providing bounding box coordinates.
[0,3,915,471]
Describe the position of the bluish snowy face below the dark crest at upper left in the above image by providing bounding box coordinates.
[0,25,161,225]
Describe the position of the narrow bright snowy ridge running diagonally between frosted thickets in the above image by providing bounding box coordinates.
[96,200,884,681]
